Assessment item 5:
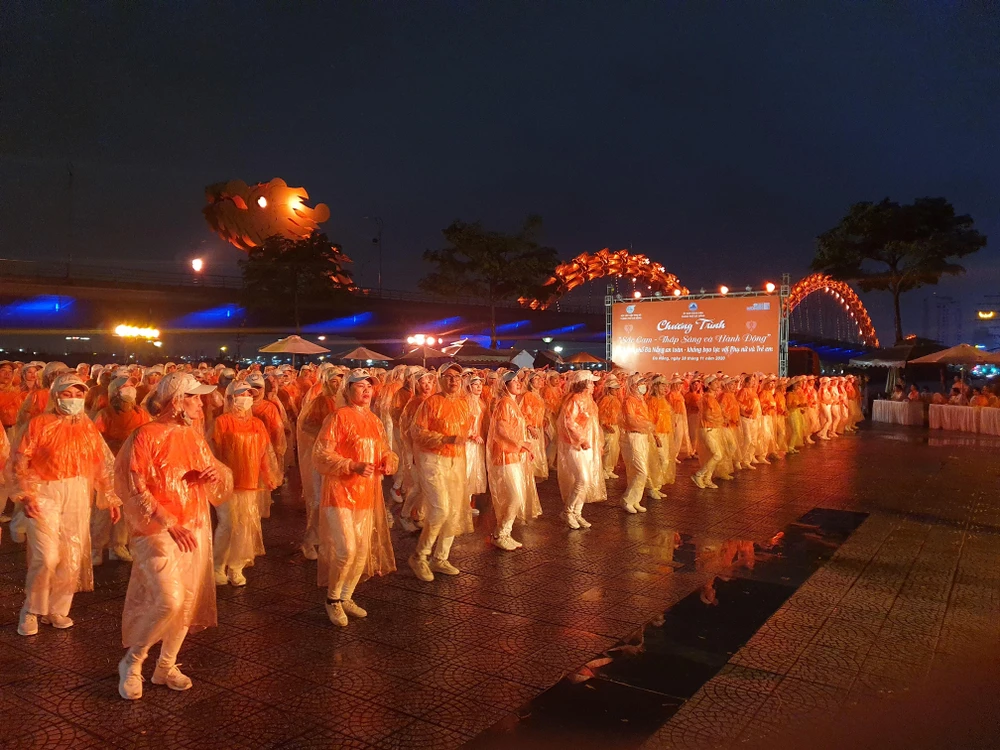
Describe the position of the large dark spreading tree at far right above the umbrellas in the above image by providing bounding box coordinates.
[812,198,986,342]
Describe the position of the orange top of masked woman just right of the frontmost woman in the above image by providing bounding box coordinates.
[212,412,281,491]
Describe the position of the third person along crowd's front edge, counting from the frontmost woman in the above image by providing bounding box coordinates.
[409,364,473,581]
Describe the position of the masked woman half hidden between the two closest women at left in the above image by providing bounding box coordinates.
[90,378,150,567]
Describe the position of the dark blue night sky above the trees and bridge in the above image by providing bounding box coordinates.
[0,0,1000,334]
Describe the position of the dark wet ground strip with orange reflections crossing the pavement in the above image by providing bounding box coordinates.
[468,508,868,750]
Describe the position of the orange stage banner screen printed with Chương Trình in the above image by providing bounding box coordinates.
[611,295,781,375]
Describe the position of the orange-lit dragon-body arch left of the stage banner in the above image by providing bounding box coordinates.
[518,248,688,310]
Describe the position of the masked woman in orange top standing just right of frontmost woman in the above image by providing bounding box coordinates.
[211,380,281,586]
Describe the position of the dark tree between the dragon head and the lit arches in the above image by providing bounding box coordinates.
[420,215,558,349]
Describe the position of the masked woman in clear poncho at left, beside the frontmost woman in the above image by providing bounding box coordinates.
[12,371,121,635]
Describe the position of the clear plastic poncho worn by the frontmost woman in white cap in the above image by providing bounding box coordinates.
[115,417,233,647]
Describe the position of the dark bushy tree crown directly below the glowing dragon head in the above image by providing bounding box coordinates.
[240,232,354,331]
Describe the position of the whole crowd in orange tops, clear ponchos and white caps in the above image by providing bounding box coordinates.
[0,361,863,699]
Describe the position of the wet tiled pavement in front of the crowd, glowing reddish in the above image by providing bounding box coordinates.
[0,428,1000,748]
